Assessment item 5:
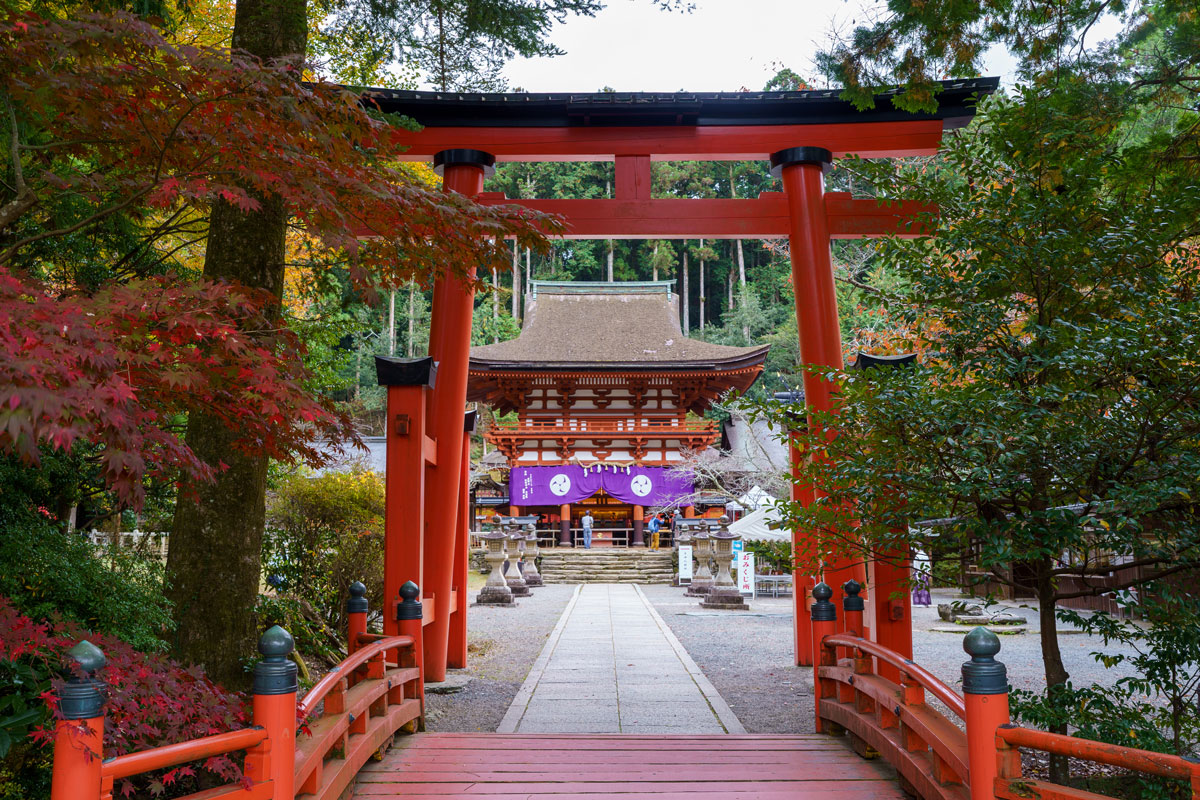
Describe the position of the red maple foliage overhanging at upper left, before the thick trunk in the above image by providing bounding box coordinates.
[0,14,553,506]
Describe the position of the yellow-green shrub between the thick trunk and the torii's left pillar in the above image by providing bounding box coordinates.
[263,469,384,632]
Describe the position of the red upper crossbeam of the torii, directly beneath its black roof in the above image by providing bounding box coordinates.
[389,120,942,161]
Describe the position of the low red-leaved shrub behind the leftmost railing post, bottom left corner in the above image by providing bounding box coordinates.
[0,597,250,800]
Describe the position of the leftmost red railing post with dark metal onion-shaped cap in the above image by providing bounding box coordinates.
[50,640,107,800]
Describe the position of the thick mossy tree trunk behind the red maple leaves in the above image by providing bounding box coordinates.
[167,0,308,688]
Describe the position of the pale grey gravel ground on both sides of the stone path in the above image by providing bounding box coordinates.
[426,584,1128,733]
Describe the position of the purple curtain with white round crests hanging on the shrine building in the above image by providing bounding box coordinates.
[509,464,695,506]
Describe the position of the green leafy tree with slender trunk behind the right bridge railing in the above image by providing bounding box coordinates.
[758,89,1200,777]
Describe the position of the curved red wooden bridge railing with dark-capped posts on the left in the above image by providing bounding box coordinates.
[50,582,425,800]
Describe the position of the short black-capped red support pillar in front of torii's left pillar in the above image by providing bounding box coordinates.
[376,356,437,636]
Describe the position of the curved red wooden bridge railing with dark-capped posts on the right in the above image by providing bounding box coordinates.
[811,582,1200,800]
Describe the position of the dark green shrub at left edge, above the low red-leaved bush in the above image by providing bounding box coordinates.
[0,521,174,651]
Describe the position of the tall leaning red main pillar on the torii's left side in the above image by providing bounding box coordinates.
[421,150,496,681]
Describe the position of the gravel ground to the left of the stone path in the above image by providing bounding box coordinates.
[425,584,575,732]
